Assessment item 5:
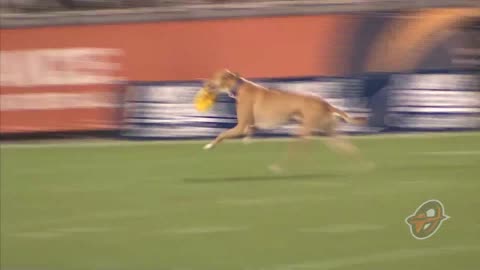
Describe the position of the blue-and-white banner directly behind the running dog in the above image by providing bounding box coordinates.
[123,78,376,139]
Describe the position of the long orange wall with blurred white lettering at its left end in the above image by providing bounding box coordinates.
[0,15,355,133]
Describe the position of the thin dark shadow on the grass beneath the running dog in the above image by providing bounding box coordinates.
[183,173,346,184]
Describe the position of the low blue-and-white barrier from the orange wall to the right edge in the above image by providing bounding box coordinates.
[122,71,480,139]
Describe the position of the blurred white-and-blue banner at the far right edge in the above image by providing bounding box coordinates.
[372,73,480,131]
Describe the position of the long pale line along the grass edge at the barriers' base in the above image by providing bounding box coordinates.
[0,132,480,149]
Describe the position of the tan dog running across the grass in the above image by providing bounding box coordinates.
[204,70,366,169]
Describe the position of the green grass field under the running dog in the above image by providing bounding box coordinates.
[1,133,480,270]
